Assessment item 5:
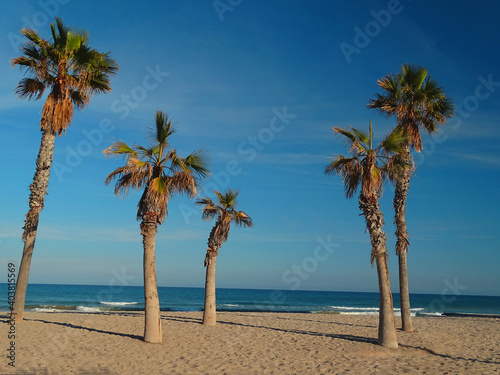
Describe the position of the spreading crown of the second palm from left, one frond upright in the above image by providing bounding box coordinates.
[104,111,209,224]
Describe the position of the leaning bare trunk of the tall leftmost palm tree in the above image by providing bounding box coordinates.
[12,131,56,323]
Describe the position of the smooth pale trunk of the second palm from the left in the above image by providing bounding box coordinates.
[141,215,162,343]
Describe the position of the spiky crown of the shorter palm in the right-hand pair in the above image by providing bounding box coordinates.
[325,121,407,203]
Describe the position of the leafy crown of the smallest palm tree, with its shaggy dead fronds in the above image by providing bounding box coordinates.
[195,189,253,267]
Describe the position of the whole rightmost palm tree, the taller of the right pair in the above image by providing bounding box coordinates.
[368,65,454,332]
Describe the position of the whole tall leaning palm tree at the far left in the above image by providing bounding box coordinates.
[11,18,118,323]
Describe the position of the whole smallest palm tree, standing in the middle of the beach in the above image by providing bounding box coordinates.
[196,189,253,326]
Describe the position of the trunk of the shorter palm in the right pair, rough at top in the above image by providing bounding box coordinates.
[359,197,398,348]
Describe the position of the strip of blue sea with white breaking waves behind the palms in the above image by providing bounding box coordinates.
[0,284,500,317]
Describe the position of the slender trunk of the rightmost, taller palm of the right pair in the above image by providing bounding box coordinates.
[394,146,413,332]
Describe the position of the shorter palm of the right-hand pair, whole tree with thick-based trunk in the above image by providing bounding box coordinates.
[325,121,405,348]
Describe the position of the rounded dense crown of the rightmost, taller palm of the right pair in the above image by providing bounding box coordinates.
[368,64,454,152]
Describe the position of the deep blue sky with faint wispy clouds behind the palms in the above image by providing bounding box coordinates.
[0,0,500,295]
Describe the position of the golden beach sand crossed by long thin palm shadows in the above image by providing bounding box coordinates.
[0,312,500,375]
